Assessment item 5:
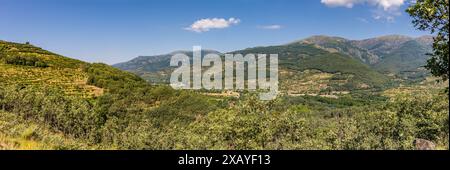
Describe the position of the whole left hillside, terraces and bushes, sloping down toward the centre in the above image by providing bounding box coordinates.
[0,41,228,149]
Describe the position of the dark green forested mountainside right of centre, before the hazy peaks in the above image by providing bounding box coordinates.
[233,43,389,92]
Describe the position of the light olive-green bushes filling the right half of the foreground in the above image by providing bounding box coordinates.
[175,92,448,149]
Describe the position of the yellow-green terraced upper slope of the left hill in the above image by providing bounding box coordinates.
[0,41,103,97]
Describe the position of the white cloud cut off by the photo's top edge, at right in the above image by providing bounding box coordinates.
[321,0,405,11]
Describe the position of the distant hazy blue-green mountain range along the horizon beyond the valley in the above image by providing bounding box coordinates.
[113,35,433,94]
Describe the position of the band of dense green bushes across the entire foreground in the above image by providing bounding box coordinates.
[0,83,449,149]
